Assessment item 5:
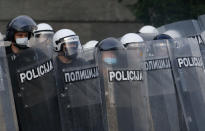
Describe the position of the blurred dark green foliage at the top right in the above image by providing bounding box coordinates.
[124,0,205,26]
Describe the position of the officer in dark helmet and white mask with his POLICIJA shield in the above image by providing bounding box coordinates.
[5,16,60,131]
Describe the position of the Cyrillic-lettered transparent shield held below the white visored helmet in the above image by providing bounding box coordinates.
[54,50,105,131]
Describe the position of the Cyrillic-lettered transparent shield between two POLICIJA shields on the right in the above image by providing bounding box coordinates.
[145,41,183,131]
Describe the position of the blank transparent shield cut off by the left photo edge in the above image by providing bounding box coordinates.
[0,41,19,131]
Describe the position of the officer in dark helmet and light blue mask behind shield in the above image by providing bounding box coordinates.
[96,37,139,131]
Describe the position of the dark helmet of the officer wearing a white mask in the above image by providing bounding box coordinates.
[5,15,37,43]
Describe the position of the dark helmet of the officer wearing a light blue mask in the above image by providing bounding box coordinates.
[96,37,124,51]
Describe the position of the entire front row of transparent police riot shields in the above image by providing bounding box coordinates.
[0,38,205,131]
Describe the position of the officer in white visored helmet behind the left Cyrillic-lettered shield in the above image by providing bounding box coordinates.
[53,29,103,131]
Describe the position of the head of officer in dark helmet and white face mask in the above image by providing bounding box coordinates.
[5,15,36,54]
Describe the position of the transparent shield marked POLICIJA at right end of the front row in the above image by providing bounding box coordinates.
[168,38,205,131]
